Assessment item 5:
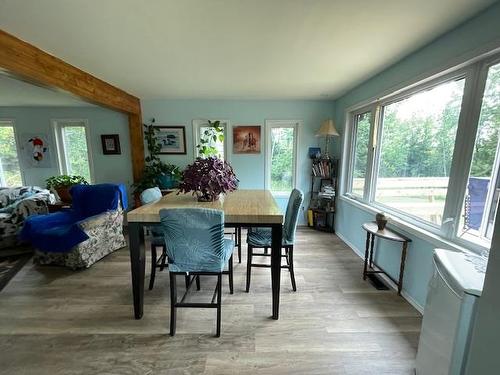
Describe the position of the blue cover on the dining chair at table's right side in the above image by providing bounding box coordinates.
[247,189,304,247]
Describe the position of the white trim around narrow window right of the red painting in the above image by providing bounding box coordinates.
[264,120,303,198]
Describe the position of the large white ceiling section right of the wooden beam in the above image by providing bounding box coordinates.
[0,0,494,99]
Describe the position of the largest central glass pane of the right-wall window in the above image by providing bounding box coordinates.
[375,79,465,225]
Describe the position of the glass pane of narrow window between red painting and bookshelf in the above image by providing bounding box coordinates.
[271,128,295,192]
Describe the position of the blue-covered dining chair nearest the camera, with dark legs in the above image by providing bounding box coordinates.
[160,208,234,337]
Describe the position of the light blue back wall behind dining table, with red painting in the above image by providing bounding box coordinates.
[142,100,334,223]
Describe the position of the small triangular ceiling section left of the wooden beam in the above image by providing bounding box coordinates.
[0,74,93,107]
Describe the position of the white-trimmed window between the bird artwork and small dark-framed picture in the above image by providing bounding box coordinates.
[54,120,93,182]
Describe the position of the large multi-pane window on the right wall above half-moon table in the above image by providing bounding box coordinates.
[345,55,500,250]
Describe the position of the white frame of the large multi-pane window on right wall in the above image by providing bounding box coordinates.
[340,49,500,252]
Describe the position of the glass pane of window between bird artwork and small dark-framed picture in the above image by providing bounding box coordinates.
[63,126,91,182]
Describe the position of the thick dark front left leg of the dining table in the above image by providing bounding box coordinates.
[128,223,146,319]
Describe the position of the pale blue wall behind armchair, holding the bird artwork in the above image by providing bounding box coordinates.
[0,107,133,192]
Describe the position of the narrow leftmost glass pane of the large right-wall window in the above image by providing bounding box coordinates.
[351,112,371,196]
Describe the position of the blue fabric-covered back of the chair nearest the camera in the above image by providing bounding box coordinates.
[160,208,227,272]
